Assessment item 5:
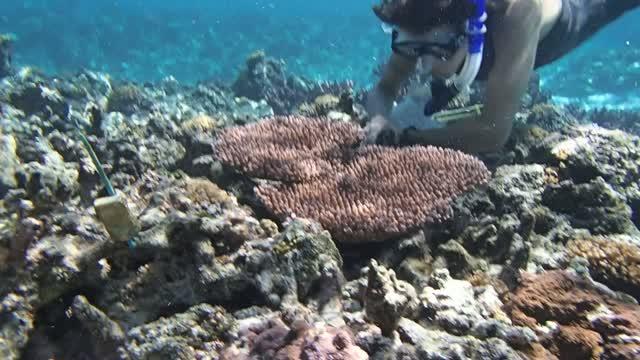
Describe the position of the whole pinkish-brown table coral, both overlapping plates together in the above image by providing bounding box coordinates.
[215,117,489,242]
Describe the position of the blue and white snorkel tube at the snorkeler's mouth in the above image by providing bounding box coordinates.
[424,0,487,116]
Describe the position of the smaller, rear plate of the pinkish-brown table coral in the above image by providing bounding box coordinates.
[214,116,361,182]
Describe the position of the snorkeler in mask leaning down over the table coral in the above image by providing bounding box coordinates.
[364,0,640,152]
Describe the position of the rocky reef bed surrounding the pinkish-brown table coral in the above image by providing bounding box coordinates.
[0,54,640,359]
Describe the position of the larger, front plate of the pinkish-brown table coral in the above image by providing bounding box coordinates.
[256,146,489,242]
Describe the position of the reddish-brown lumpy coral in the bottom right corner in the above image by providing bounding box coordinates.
[505,271,640,359]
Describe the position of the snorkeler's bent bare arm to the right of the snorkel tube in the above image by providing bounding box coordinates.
[403,0,542,152]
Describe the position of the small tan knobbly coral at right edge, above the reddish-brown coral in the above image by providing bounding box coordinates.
[567,237,640,299]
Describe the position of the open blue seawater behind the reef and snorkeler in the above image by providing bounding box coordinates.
[0,0,640,107]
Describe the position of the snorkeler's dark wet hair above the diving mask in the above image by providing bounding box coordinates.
[373,0,490,33]
